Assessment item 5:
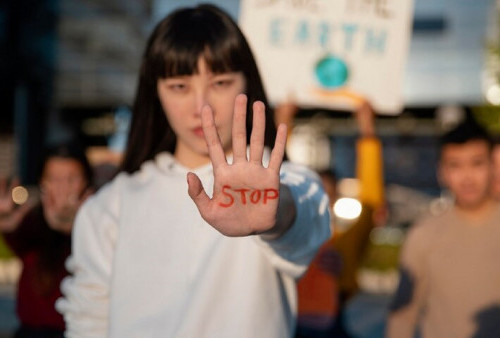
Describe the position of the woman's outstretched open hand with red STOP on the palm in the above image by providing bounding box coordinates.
[187,94,287,236]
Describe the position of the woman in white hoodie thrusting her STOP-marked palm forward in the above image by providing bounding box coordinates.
[57,5,330,338]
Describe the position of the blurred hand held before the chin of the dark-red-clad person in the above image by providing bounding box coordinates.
[42,184,93,234]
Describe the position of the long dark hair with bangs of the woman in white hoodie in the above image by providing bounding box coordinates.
[120,4,276,173]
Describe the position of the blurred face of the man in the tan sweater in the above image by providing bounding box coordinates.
[439,140,493,208]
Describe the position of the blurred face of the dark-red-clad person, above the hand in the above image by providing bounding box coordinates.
[40,157,88,199]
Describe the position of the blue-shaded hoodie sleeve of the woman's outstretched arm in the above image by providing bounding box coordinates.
[256,162,331,278]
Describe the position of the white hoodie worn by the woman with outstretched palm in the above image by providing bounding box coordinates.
[56,153,330,338]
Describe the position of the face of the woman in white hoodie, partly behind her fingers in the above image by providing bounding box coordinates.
[157,57,246,168]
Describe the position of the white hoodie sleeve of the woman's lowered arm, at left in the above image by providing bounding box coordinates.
[56,178,118,338]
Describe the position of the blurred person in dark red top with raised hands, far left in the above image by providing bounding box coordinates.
[0,144,92,338]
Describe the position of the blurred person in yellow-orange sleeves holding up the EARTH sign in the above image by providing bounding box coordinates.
[276,93,385,338]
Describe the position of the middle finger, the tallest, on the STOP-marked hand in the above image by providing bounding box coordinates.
[232,94,247,163]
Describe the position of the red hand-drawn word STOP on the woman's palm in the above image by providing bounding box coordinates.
[219,185,279,208]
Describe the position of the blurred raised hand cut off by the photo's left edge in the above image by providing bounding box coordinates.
[0,178,34,232]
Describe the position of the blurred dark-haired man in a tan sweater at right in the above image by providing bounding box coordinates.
[387,118,500,338]
